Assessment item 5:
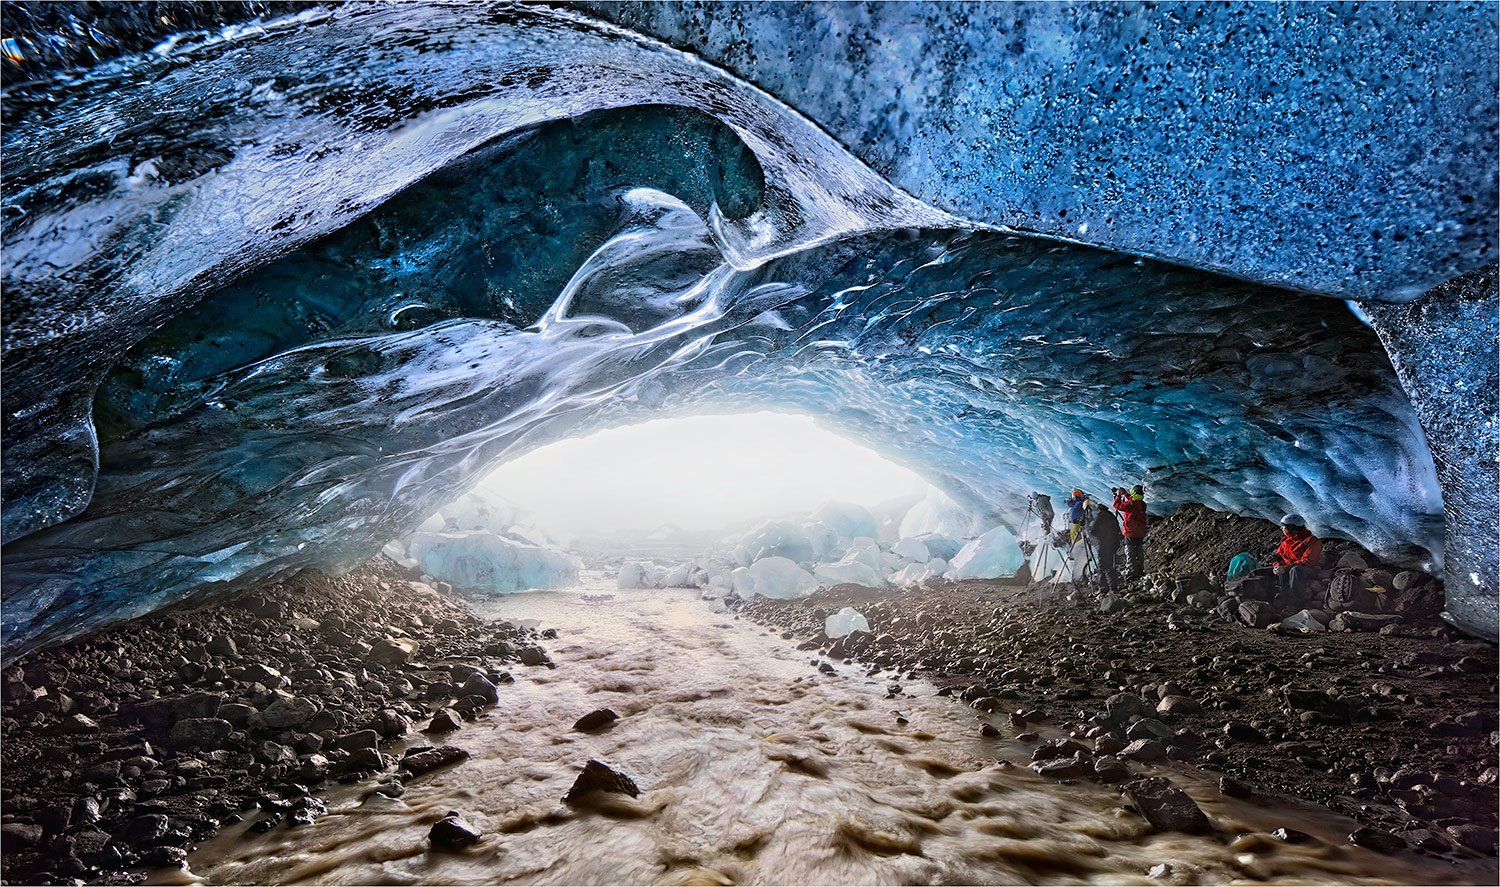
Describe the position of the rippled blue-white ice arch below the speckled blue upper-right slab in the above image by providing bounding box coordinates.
[3,6,1496,656]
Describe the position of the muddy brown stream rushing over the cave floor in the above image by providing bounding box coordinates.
[175,578,1496,884]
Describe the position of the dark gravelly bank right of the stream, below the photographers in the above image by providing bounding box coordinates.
[737,581,1500,858]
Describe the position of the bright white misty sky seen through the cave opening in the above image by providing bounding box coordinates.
[482,413,927,536]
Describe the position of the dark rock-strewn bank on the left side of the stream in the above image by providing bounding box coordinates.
[0,558,549,884]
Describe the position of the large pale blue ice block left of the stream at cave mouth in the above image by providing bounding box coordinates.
[408,530,584,594]
